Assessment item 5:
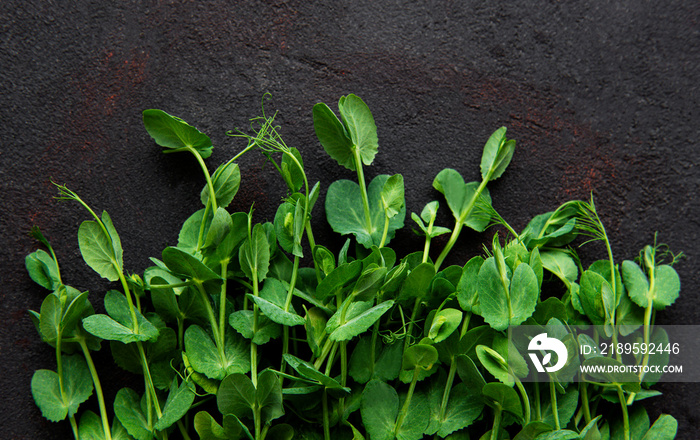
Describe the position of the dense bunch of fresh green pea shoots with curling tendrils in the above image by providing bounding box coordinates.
[26,95,680,440]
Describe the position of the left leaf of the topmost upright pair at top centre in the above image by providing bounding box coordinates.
[313,103,355,171]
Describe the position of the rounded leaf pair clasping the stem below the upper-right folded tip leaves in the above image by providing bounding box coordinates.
[433,168,491,232]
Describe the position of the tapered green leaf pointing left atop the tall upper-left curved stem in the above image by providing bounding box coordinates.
[143,109,214,159]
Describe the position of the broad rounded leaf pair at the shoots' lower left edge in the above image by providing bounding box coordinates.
[31,355,93,422]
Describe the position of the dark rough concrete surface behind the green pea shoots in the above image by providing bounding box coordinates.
[0,0,700,439]
